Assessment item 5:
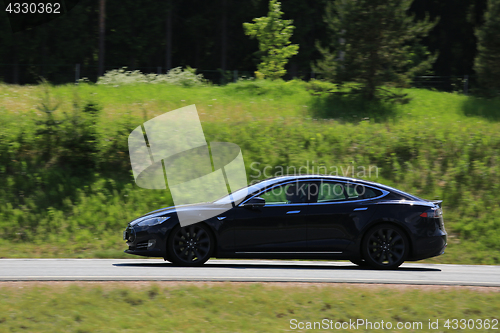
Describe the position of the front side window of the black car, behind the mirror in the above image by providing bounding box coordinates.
[259,182,311,205]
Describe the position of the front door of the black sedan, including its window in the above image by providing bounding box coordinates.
[226,181,311,253]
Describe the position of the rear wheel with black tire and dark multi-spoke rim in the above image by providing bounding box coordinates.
[362,224,409,269]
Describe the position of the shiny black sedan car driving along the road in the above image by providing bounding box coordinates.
[123,175,447,269]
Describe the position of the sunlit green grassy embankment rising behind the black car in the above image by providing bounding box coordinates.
[0,81,500,264]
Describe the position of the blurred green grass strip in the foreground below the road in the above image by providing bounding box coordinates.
[0,283,500,333]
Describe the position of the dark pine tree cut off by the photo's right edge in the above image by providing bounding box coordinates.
[474,0,500,94]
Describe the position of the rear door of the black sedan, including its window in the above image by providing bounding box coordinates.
[307,181,383,253]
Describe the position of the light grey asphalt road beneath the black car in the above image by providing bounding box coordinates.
[0,259,500,287]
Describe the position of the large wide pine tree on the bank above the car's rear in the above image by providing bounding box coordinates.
[315,0,437,100]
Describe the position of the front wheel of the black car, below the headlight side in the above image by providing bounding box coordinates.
[167,223,214,266]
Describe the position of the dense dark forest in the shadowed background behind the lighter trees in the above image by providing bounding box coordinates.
[0,0,486,84]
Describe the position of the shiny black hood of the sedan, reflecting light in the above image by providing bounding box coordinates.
[129,202,232,226]
